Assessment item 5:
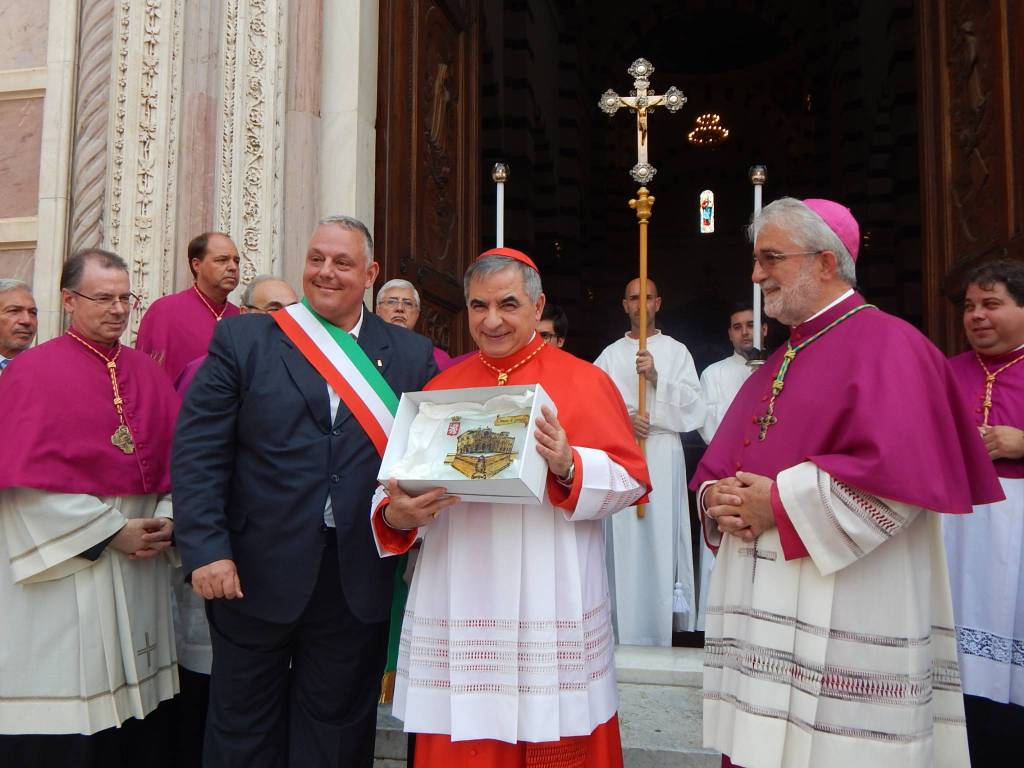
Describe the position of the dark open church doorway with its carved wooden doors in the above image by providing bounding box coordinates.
[377,0,1024,368]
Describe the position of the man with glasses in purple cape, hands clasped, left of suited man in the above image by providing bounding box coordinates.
[0,250,178,768]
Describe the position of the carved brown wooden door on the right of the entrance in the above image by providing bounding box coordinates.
[918,0,1024,352]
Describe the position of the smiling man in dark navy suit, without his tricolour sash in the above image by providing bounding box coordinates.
[172,216,436,768]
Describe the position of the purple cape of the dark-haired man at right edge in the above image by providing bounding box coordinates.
[949,349,1024,479]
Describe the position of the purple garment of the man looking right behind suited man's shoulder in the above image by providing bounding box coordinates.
[135,286,239,383]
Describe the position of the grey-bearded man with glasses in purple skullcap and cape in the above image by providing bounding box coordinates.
[692,198,1002,768]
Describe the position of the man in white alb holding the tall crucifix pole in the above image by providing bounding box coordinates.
[594,280,705,646]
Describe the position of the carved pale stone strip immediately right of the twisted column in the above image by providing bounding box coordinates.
[105,0,183,338]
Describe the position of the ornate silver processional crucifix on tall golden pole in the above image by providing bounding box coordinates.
[597,58,686,517]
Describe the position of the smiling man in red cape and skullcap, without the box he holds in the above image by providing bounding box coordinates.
[371,249,650,768]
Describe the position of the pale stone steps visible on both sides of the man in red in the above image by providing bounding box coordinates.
[374,646,721,768]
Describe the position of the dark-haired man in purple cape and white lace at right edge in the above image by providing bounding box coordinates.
[942,260,1024,766]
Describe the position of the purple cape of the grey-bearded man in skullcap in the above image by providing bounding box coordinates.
[690,293,1004,514]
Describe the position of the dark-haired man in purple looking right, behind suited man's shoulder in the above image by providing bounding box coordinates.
[135,232,239,383]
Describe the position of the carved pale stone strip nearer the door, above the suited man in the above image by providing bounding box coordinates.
[216,0,288,289]
